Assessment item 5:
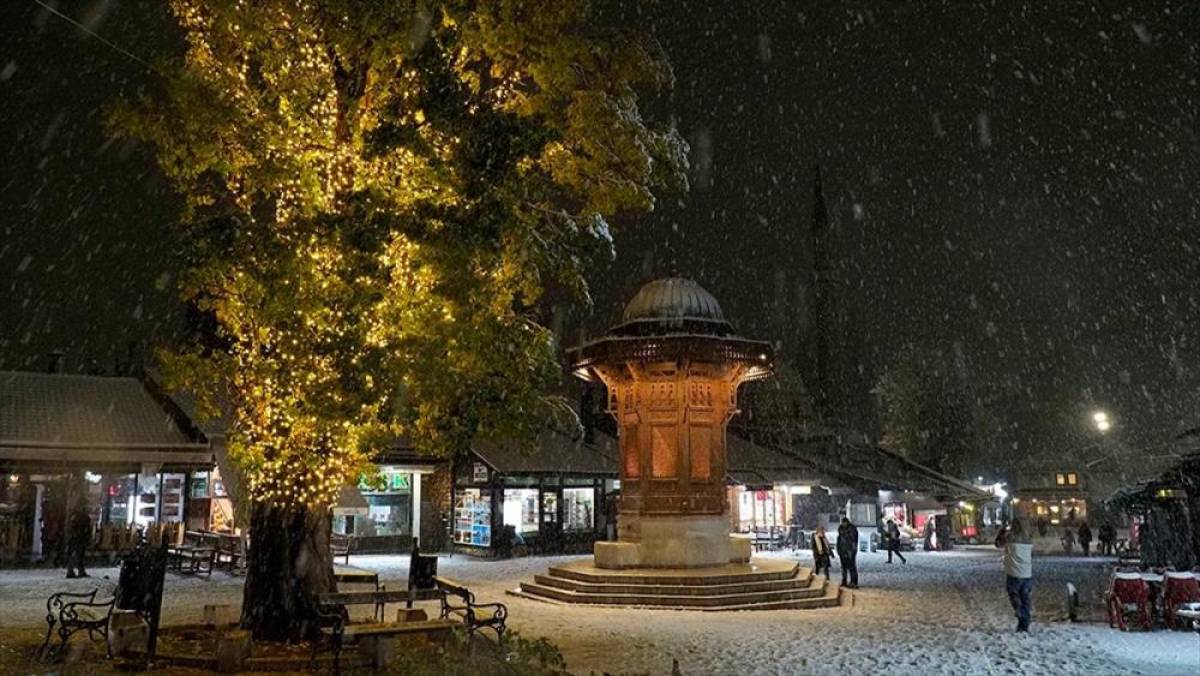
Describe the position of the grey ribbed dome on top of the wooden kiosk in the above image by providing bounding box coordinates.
[614,277,730,334]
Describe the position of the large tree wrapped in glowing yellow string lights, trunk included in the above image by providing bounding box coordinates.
[119,0,686,639]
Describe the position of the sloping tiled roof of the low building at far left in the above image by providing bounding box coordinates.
[0,371,203,448]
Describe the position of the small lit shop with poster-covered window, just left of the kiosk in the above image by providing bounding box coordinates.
[451,432,619,556]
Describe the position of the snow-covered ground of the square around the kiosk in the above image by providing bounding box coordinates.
[0,548,1200,675]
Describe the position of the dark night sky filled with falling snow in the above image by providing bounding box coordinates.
[0,0,1200,475]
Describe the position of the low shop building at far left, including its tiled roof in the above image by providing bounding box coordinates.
[0,371,215,562]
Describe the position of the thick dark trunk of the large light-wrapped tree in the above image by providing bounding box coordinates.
[241,502,336,641]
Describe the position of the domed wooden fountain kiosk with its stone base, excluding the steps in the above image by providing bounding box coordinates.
[571,277,772,569]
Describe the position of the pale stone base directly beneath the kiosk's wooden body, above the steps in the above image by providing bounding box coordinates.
[594,515,750,570]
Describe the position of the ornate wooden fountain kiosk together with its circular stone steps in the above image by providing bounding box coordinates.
[509,277,842,610]
